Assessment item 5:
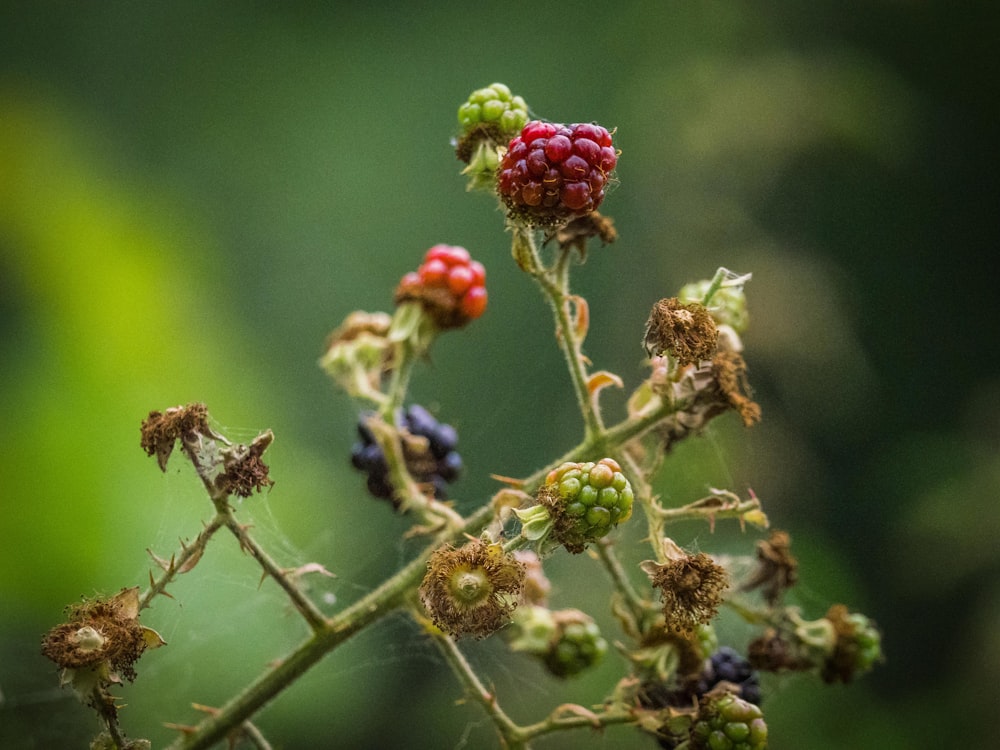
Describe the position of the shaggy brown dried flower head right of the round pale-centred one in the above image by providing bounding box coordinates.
[642,539,729,633]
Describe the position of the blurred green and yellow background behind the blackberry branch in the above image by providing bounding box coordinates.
[0,0,1000,750]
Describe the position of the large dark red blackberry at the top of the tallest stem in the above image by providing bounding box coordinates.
[497,120,618,226]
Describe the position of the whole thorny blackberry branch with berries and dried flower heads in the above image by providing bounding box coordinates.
[42,83,881,750]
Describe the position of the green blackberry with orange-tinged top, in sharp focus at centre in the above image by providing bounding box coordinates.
[538,458,635,553]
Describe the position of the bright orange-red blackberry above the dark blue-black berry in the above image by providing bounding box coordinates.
[396,244,487,328]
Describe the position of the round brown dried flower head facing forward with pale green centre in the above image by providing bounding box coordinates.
[420,539,525,638]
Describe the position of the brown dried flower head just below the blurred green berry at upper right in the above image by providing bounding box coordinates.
[643,297,719,367]
